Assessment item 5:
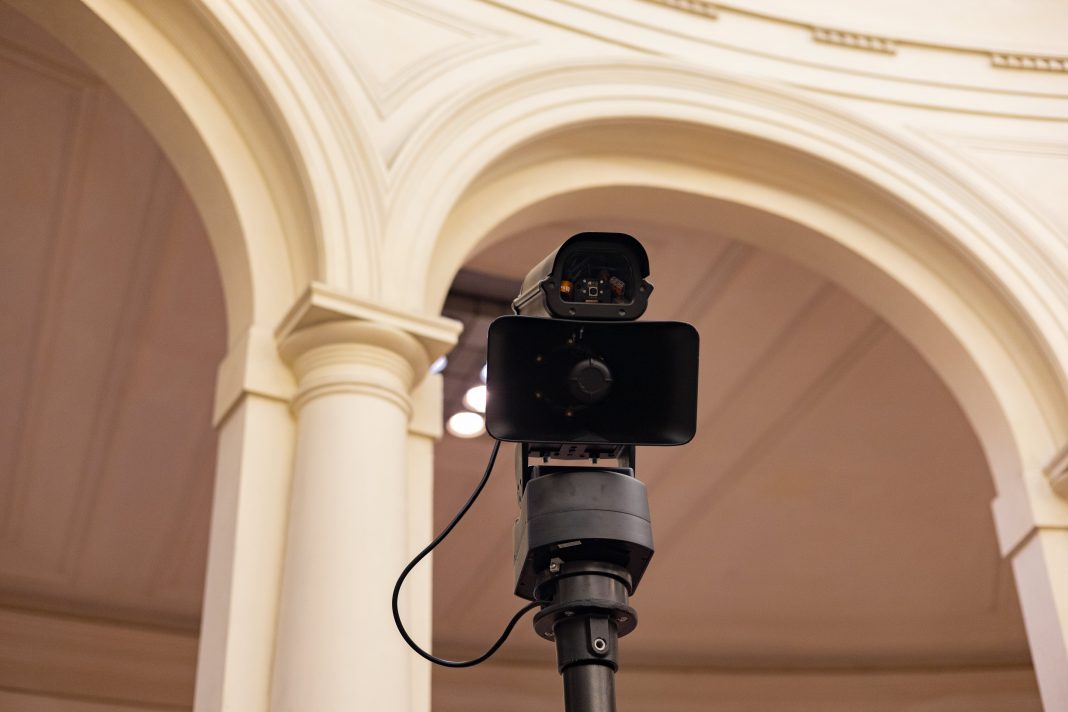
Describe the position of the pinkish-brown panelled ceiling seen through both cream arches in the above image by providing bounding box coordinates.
[0,4,1038,712]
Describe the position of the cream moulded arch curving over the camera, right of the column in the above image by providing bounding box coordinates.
[387,60,1068,505]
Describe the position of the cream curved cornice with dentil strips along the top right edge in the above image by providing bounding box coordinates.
[495,0,1068,120]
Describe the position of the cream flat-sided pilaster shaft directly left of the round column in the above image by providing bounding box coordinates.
[194,393,293,712]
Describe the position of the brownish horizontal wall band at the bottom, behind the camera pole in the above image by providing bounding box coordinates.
[434,653,1041,712]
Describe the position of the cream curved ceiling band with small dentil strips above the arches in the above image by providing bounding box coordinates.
[555,0,1068,118]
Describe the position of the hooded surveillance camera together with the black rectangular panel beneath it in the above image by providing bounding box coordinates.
[486,233,700,459]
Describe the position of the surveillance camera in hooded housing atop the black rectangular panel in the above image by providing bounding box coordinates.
[512,233,653,321]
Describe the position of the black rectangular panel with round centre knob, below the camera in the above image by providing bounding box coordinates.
[486,316,698,445]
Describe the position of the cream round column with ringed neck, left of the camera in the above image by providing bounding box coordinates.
[270,319,429,712]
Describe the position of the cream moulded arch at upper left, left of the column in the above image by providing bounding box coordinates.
[12,0,325,348]
